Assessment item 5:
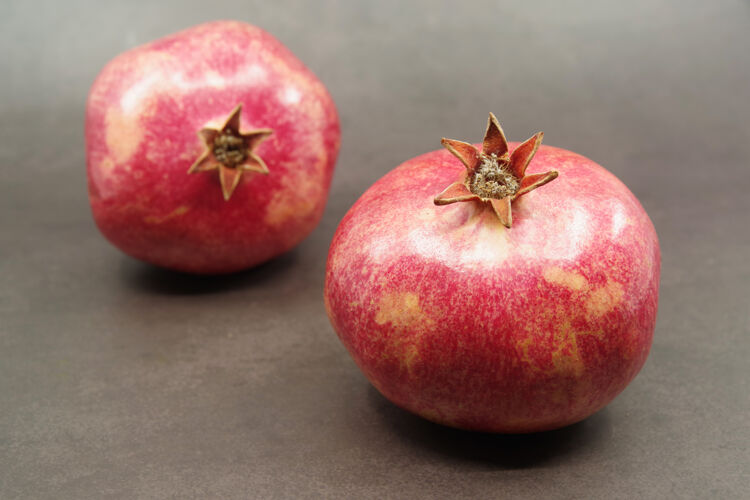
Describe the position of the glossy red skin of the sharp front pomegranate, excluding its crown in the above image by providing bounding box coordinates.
[325,143,660,433]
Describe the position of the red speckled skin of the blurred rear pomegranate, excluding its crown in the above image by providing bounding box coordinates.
[86,21,340,273]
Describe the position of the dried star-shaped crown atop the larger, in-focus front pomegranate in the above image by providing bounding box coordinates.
[435,113,557,227]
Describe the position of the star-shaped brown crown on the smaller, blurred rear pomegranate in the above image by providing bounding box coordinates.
[188,104,273,200]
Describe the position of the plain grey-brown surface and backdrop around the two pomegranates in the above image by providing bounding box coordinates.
[0,0,750,499]
